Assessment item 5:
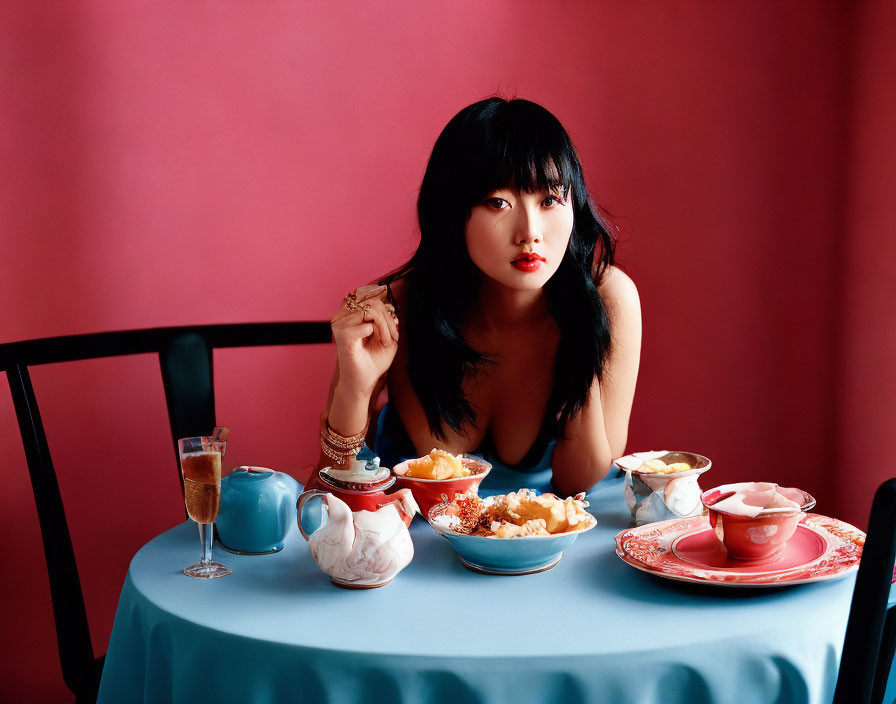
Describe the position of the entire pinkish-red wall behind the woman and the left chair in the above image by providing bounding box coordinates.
[0,0,896,701]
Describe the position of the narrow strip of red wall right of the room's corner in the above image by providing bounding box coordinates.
[831,0,896,540]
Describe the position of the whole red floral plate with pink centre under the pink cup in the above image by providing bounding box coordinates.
[616,513,865,587]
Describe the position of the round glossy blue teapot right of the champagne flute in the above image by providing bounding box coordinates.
[215,467,300,555]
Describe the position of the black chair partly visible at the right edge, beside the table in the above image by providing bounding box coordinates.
[834,479,896,704]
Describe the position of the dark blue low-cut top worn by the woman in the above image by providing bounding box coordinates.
[374,404,556,496]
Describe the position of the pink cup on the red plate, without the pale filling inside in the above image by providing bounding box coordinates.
[700,487,815,561]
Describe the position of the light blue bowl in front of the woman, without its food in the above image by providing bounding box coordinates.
[427,504,597,575]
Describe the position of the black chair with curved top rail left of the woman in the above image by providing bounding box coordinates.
[0,321,331,702]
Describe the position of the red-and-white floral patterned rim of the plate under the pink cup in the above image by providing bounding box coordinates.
[616,513,865,587]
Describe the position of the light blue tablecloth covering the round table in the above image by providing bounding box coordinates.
[99,478,855,704]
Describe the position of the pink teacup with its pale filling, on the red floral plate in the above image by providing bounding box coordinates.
[700,482,815,561]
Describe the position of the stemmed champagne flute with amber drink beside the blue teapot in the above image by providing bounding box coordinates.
[177,434,233,579]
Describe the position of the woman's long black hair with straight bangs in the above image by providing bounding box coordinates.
[382,97,614,439]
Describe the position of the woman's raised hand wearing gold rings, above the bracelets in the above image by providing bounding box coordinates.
[330,286,398,396]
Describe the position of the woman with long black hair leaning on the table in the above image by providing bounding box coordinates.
[321,98,641,495]
